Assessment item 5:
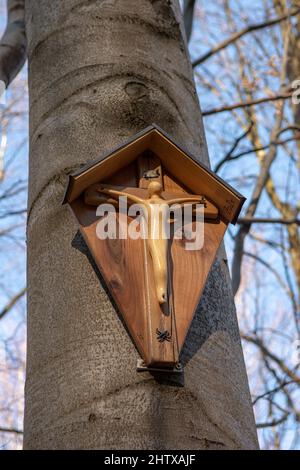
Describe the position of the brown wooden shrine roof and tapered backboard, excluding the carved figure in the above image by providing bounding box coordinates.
[64,126,244,370]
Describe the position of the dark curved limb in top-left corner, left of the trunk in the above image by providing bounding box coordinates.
[0,0,26,91]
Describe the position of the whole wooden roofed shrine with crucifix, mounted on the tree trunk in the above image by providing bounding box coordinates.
[64,125,245,372]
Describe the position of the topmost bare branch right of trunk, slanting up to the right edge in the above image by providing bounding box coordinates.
[192,8,300,67]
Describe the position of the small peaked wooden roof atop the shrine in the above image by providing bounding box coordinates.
[63,124,245,223]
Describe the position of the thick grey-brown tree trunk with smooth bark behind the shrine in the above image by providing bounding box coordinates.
[24,0,258,449]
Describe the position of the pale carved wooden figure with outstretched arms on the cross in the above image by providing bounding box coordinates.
[85,181,203,304]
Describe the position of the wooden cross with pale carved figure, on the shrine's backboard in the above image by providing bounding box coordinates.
[84,181,218,370]
